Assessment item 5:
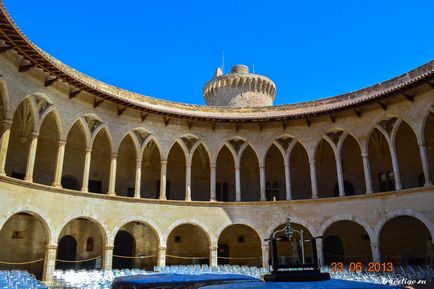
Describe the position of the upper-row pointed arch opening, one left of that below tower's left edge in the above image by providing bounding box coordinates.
[166,142,185,200]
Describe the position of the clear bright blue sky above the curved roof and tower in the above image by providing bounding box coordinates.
[4,0,434,104]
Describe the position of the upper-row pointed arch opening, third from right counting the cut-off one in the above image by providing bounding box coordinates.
[368,129,395,192]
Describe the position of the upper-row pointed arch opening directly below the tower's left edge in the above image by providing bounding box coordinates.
[191,144,210,201]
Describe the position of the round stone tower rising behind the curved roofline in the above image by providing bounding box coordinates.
[203,65,276,107]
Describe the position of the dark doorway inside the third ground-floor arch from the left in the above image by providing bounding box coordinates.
[113,230,135,269]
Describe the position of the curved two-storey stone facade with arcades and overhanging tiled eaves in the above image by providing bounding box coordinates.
[0,1,434,280]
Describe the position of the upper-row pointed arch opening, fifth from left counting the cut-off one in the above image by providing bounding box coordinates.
[88,128,110,194]
